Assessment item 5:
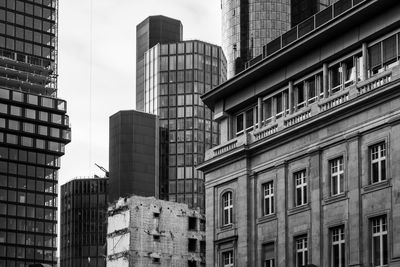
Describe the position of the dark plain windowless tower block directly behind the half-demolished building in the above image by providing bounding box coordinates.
[109,110,168,202]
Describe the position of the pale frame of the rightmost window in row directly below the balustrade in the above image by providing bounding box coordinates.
[368,141,388,185]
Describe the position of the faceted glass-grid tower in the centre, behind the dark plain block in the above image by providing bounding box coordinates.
[144,40,226,209]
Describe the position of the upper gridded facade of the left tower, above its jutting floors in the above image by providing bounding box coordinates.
[0,0,58,96]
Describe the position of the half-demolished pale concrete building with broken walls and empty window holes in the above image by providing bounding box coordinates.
[107,196,205,267]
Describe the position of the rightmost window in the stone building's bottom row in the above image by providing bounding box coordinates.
[371,216,388,266]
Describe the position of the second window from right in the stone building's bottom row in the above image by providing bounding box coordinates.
[331,226,346,267]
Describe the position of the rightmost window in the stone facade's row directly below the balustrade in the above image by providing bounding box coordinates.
[370,142,386,184]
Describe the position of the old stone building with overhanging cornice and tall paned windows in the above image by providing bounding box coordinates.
[199,0,400,267]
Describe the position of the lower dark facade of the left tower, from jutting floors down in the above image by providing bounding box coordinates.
[0,88,71,267]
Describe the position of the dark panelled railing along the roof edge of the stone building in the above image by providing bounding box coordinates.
[245,0,368,69]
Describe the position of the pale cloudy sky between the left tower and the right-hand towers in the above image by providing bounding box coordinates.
[58,0,221,185]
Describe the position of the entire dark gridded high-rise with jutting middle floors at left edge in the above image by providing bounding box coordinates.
[0,0,70,267]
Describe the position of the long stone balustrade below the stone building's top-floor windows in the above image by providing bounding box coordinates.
[205,65,400,160]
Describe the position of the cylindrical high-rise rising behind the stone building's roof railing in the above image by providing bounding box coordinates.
[221,0,334,78]
